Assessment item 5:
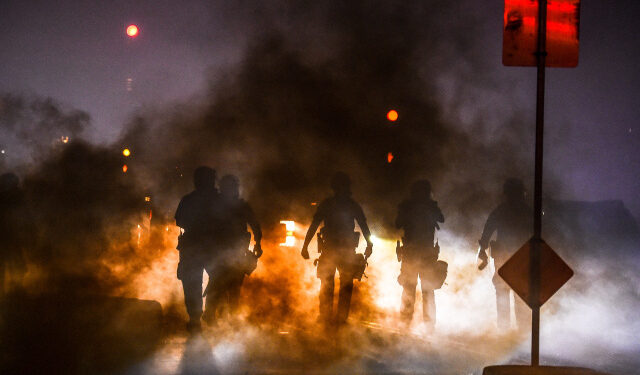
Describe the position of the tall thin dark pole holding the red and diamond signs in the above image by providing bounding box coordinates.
[529,0,547,366]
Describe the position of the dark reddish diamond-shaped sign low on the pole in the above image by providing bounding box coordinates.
[498,241,573,307]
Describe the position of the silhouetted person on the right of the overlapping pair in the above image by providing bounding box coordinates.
[204,175,262,323]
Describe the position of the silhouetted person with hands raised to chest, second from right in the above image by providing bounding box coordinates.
[396,180,446,327]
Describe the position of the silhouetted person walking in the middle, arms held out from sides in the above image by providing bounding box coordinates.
[301,172,373,325]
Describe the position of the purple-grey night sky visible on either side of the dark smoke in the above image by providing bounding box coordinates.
[0,0,640,217]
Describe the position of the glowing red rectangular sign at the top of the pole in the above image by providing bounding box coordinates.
[502,0,580,68]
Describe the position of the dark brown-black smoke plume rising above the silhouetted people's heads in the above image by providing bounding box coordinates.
[121,2,531,238]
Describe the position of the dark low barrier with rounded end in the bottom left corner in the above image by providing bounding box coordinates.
[0,294,163,374]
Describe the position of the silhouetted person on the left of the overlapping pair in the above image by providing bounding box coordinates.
[175,167,219,332]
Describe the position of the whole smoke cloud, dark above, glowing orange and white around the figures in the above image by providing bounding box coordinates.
[0,1,640,371]
